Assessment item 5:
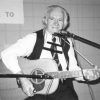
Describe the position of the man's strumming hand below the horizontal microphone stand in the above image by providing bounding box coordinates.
[19,78,36,96]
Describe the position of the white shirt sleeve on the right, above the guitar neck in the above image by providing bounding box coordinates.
[68,38,80,70]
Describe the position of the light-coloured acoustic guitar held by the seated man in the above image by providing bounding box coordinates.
[18,58,97,95]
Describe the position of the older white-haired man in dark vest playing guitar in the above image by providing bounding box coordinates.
[1,5,99,100]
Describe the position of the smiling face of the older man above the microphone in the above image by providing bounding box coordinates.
[47,9,64,34]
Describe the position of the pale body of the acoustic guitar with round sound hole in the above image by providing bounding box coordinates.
[18,58,59,95]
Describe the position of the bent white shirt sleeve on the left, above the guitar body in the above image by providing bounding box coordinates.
[1,33,36,74]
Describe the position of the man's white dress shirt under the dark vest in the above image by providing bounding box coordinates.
[1,32,80,74]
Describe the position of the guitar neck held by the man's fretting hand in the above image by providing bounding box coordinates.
[46,69,100,79]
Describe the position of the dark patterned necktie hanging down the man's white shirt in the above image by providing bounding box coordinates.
[51,37,62,71]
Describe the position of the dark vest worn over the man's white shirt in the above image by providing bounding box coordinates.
[27,29,69,65]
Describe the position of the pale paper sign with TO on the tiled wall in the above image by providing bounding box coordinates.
[0,0,24,24]
